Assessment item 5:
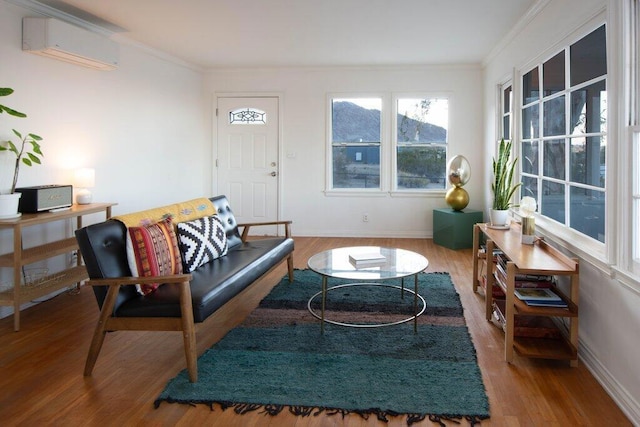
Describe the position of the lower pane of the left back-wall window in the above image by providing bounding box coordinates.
[333,145,380,188]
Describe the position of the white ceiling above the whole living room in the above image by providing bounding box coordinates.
[20,0,537,69]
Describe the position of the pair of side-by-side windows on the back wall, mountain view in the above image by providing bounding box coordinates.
[329,96,449,191]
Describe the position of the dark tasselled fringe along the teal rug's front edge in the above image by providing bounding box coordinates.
[153,399,489,427]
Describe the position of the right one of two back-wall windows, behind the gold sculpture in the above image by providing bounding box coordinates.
[395,98,449,190]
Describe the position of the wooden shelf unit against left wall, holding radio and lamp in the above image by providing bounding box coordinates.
[0,203,116,331]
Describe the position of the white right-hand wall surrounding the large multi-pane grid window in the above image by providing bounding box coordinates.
[483,0,640,424]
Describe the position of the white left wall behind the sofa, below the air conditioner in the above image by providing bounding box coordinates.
[0,1,211,314]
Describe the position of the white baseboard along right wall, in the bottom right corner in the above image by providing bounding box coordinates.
[579,340,640,426]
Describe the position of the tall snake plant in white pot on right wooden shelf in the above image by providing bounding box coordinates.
[489,139,522,227]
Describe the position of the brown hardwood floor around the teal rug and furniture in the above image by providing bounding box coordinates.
[0,237,631,427]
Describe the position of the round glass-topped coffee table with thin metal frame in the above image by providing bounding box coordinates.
[307,246,429,333]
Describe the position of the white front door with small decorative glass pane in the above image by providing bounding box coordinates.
[217,97,280,235]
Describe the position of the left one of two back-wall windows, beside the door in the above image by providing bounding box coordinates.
[331,98,382,189]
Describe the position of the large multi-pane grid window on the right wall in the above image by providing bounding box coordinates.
[520,25,607,243]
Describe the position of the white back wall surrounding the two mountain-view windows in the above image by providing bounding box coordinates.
[207,66,484,237]
